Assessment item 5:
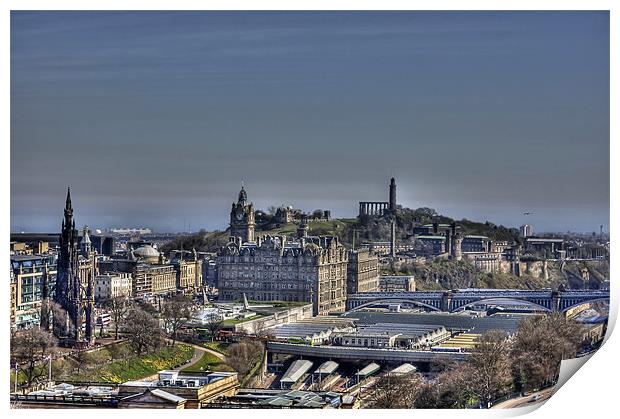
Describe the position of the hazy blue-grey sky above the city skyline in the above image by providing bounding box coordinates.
[11,12,609,231]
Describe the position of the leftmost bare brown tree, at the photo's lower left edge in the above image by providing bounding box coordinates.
[11,327,57,387]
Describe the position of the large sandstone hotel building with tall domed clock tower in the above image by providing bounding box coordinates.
[217,188,348,315]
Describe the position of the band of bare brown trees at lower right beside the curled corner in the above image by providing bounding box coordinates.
[370,313,583,409]
